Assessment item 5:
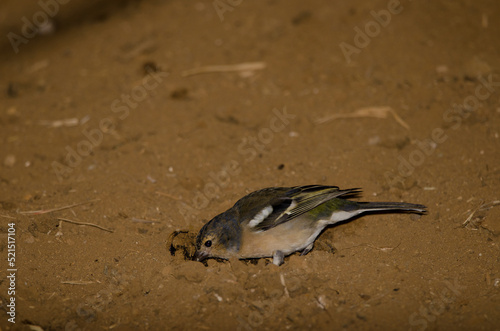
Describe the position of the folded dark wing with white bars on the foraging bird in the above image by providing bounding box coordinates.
[237,185,360,231]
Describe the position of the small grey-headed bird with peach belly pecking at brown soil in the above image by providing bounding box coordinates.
[194,185,426,266]
